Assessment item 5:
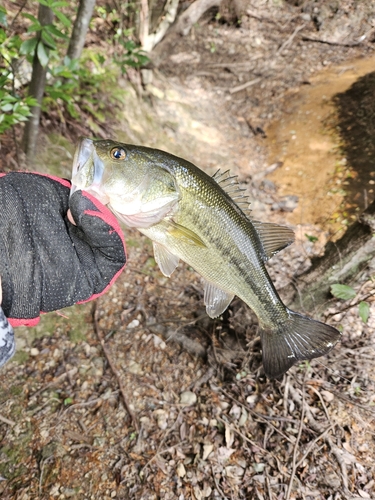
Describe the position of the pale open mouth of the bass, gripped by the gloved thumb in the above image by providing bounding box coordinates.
[70,137,109,205]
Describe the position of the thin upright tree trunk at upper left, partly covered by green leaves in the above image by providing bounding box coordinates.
[22,4,53,163]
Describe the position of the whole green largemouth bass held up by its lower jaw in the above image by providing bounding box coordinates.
[72,138,341,378]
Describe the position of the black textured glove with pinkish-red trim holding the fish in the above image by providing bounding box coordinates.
[0,172,126,326]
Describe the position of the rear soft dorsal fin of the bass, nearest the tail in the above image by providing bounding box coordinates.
[251,220,294,260]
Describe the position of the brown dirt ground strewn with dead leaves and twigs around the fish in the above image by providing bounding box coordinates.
[0,0,375,500]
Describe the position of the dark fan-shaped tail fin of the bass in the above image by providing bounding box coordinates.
[260,310,341,378]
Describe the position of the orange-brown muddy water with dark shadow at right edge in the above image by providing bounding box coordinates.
[267,57,375,236]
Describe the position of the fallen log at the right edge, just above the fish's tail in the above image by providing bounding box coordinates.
[280,201,375,312]
